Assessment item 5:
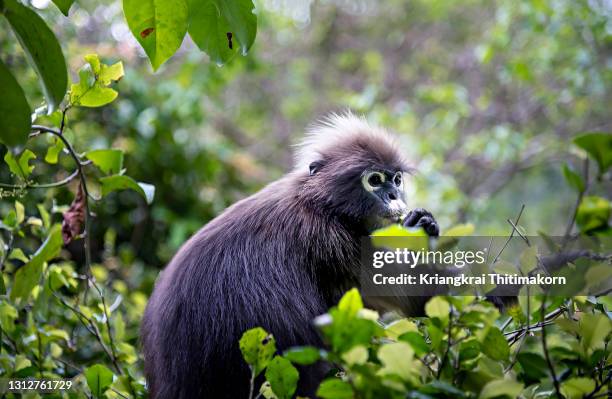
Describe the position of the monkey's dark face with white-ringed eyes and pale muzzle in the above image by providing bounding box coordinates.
[361,169,408,230]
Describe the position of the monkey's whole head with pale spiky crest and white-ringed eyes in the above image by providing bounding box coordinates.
[296,113,411,232]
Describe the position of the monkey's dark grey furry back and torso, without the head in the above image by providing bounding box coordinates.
[142,178,356,399]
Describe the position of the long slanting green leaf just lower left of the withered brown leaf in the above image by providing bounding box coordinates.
[11,224,64,301]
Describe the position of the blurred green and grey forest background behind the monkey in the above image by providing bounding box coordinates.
[0,0,612,267]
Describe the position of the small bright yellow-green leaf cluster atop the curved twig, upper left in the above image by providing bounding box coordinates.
[70,54,124,107]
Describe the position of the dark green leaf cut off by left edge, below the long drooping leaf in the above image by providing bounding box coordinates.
[0,60,32,147]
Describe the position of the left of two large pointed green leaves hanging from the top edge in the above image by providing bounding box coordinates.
[123,0,188,70]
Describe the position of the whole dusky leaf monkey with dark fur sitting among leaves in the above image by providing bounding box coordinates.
[142,113,438,399]
